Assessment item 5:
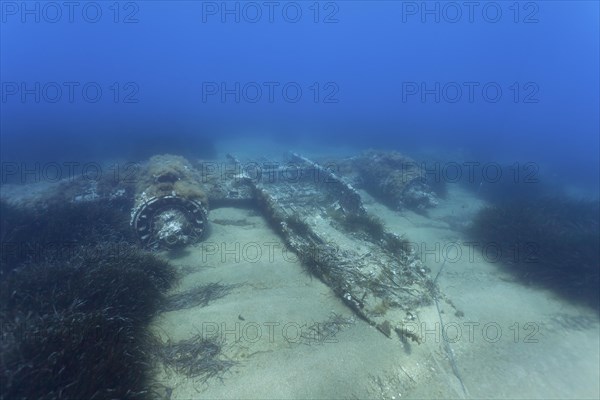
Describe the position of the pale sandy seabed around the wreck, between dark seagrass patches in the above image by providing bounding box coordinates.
[152,163,600,400]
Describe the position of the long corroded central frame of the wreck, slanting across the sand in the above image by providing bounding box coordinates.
[225,154,435,336]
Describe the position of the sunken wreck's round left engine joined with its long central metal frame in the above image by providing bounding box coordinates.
[3,154,437,341]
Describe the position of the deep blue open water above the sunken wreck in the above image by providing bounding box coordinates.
[0,1,600,195]
